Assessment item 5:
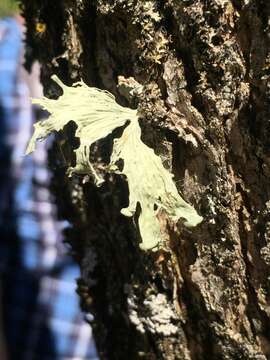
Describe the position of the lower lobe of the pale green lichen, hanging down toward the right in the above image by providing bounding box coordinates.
[111,120,201,249]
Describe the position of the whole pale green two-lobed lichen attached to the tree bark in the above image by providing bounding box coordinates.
[27,76,202,250]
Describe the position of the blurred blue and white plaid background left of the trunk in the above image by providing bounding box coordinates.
[0,0,97,360]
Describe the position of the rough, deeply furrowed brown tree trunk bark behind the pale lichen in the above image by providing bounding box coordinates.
[22,0,270,360]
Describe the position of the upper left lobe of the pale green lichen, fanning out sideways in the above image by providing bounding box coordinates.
[26,75,137,185]
